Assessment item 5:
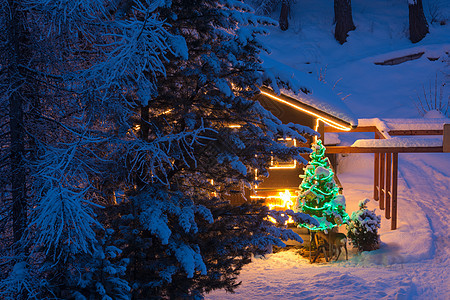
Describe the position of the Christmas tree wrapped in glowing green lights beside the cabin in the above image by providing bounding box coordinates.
[298,140,349,231]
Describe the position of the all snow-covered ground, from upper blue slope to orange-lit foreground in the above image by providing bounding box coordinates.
[207,0,450,299]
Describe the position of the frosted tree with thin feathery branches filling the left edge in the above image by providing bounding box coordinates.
[0,0,191,299]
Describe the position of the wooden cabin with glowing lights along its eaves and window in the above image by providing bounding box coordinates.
[231,82,357,209]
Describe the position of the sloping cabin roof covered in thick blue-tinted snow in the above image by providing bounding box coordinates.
[261,56,358,127]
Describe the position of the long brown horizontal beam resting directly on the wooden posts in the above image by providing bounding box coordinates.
[326,146,443,153]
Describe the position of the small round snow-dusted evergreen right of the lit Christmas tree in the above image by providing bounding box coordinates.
[347,199,381,251]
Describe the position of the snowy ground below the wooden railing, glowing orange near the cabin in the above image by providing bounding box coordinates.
[207,154,450,299]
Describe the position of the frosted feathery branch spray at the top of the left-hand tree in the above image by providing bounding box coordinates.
[81,11,187,106]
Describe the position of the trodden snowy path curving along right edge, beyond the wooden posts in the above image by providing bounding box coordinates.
[400,154,450,299]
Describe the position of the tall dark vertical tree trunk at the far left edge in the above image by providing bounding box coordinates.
[7,0,27,254]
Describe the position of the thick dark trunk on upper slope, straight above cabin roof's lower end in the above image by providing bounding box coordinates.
[334,0,356,44]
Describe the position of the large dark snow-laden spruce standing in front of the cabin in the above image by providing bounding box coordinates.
[103,1,314,298]
